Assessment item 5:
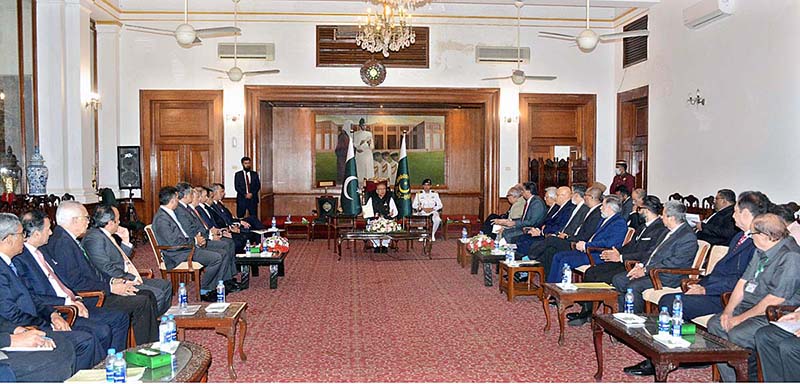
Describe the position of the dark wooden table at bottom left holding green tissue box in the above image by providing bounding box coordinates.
[94,341,211,383]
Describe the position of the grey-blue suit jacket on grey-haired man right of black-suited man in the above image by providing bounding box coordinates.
[643,223,697,287]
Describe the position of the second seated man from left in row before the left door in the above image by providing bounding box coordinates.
[175,183,243,292]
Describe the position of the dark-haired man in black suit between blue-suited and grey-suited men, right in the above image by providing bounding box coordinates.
[567,196,667,326]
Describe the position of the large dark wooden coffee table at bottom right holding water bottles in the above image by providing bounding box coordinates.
[592,315,750,382]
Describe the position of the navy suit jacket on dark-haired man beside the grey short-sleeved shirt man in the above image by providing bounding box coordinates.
[700,232,756,296]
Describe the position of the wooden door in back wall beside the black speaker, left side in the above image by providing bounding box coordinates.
[139,90,224,222]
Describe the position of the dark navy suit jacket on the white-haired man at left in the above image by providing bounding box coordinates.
[39,225,111,294]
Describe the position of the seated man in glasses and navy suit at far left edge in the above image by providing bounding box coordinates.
[0,213,103,369]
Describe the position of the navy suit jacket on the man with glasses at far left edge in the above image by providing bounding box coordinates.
[0,260,53,327]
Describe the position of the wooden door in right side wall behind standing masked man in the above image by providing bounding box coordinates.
[617,86,649,189]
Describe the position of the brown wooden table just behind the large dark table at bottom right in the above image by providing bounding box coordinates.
[542,283,619,345]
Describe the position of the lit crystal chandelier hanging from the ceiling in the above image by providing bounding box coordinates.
[356,0,419,57]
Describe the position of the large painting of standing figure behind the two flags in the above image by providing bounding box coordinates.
[315,114,446,185]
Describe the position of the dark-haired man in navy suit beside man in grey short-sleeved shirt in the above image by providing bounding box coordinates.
[658,191,770,321]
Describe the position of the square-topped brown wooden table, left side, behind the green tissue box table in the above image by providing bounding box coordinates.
[175,302,247,380]
